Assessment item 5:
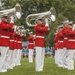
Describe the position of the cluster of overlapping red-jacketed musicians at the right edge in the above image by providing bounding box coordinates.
[54,20,75,70]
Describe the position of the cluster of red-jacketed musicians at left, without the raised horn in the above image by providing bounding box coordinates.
[0,15,25,72]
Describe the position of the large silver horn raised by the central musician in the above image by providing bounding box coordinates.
[26,6,56,27]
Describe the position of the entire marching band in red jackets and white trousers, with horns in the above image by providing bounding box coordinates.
[0,1,75,72]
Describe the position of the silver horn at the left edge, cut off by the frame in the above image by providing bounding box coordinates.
[0,3,21,19]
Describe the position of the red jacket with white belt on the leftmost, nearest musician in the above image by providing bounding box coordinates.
[0,22,14,46]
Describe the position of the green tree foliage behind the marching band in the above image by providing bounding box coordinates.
[2,0,75,46]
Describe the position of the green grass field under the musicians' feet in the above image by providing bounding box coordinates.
[0,58,75,75]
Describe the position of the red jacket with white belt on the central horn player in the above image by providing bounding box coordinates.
[34,24,49,47]
